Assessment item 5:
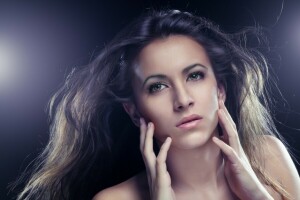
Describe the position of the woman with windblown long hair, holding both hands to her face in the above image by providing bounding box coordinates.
[19,10,300,200]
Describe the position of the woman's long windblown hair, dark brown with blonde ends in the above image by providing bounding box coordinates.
[18,10,286,199]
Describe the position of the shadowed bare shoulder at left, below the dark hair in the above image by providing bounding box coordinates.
[93,172,150,200]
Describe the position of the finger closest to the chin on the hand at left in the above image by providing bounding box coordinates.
[156,137,172,177]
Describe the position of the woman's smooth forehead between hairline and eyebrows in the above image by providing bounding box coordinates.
[135,35,211,75]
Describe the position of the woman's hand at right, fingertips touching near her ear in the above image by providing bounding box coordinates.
[213,101,273,200]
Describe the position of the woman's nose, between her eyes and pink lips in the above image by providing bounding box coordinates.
[174,84,194,111]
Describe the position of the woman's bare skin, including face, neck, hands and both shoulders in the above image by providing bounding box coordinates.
[94,36,300,200]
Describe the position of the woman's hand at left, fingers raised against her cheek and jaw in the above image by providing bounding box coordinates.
[140,118,175,200]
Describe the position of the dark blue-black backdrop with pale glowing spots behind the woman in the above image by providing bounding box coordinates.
[0,0,300,200]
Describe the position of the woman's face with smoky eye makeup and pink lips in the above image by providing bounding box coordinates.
[127,35,224,149]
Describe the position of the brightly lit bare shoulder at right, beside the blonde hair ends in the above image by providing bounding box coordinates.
[263,136,300,199]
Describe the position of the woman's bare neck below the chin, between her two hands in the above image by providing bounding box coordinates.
[167,139,225,191]
